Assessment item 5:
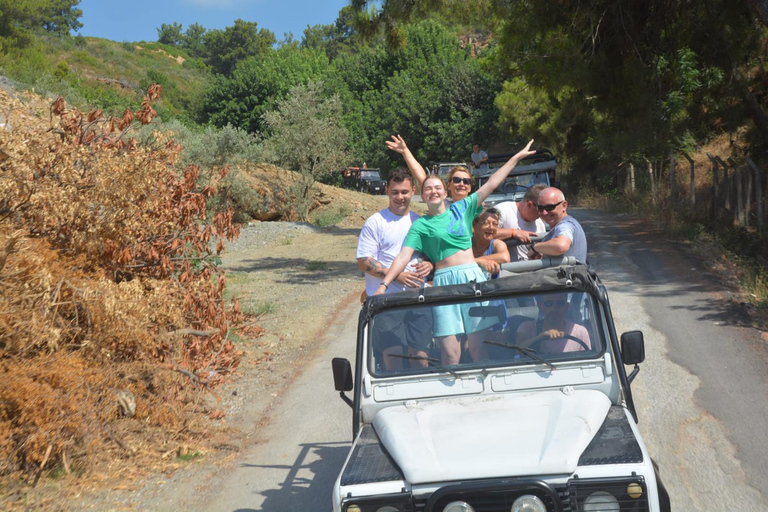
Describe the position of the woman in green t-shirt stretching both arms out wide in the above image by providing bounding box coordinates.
[375,140,536,365]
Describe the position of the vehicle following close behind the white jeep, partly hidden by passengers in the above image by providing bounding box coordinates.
[477,149,557,207]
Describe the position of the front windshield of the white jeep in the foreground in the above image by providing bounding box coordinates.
[367,291,605,377]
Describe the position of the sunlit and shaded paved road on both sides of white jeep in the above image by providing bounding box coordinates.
[180,210,768,512]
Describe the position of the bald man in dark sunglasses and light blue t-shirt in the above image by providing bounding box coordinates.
[531,187,587,263]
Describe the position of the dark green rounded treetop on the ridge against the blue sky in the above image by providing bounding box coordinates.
[203,19,277,76]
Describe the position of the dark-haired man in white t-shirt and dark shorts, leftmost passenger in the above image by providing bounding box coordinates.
[356,168,433,370]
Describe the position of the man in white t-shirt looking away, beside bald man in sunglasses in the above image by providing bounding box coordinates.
[494,183,547,261]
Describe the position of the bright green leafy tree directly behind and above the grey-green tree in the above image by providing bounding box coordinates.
[199,45,328,133]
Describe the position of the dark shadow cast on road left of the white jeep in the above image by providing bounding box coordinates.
[234,442,350,512]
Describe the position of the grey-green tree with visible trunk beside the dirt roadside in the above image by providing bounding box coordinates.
[264,82,348,221]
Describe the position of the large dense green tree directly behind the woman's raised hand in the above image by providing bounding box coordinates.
[330,22,499,169]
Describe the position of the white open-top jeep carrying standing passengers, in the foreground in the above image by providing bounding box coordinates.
[333,258,670,512]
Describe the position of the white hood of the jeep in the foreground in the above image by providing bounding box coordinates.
[373,390,611,484]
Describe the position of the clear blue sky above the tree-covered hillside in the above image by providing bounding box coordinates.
[73,0,349,42]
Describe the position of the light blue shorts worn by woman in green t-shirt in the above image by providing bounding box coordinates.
[432,263,498,337]
